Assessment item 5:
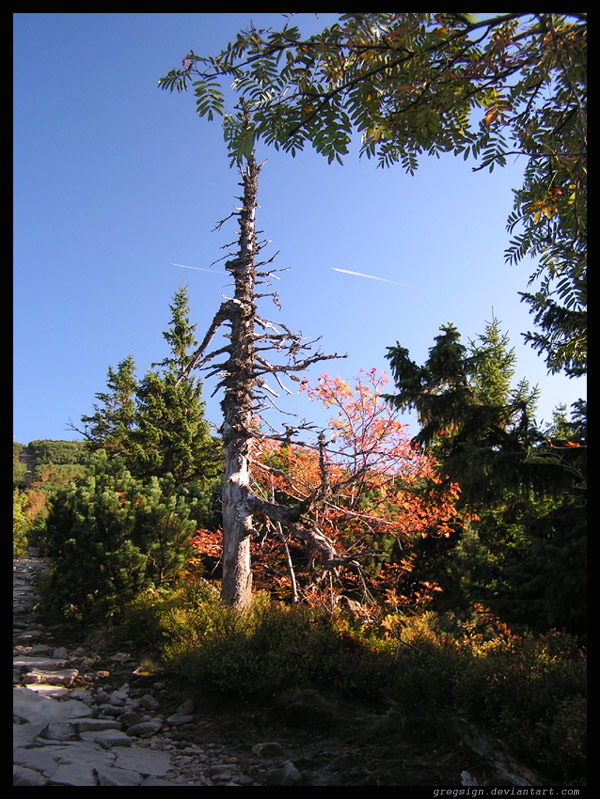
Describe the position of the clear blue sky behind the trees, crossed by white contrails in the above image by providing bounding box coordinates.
[13,13,585,444]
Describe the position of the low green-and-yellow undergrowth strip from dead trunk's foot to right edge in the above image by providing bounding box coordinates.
[103,580,586,785]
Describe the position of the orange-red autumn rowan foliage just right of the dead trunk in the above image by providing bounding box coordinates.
[198,369,459,606]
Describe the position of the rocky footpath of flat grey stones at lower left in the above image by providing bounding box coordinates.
[13,558,300,786]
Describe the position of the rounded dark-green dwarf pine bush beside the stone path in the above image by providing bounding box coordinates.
[42,456,206,624]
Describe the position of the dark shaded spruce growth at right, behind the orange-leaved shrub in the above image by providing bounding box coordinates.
[388,320,586,635]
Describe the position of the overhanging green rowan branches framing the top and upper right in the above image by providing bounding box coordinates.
[159,12,587,375]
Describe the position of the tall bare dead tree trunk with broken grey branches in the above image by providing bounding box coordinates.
[180,144,340,610]
